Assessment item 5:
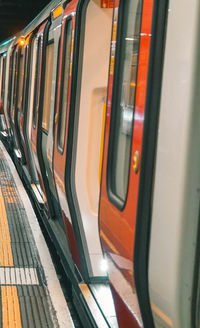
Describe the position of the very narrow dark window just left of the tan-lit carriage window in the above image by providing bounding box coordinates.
[33,38,41,129]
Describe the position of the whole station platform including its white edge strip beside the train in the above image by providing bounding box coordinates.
[0,143,74,328]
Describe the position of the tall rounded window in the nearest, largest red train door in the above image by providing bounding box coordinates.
[108,0,142,210]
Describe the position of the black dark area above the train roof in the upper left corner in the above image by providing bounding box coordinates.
[0,0,50,42]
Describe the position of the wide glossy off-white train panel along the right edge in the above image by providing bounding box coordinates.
[149,0,200,328]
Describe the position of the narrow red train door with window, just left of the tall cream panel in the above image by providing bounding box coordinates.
[53,0,81,271]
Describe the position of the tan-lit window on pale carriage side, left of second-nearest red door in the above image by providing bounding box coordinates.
[42,42,54,131]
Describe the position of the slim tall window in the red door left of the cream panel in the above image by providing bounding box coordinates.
[58,19,72,152]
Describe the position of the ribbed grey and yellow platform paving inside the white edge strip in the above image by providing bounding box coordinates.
[0,148,58,328]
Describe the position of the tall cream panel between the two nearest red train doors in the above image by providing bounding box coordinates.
[72,0,113,280]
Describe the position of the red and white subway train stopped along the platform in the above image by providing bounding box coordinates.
[0,0,200,328]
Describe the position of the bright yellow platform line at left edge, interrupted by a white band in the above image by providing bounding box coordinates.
[0,189,22,328]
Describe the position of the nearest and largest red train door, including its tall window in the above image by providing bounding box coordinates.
[99,0,153,327]
